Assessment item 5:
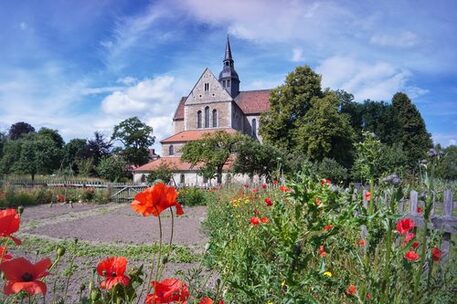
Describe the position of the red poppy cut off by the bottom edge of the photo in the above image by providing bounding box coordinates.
[145,278,189,304]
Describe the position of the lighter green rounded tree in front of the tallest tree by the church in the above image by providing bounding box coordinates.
[296,92,354,167]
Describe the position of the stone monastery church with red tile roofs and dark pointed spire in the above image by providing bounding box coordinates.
[133,37,270,186]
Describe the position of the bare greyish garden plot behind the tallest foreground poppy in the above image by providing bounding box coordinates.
[21,203,207,247]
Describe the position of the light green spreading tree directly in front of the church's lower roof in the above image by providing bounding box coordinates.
[181,131,246,184]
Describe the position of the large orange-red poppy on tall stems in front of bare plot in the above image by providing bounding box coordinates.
[131,183,184,216]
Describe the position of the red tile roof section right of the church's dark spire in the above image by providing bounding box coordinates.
[235,90,271,114]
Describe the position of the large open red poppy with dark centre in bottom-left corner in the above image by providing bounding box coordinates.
[0,258,52,295]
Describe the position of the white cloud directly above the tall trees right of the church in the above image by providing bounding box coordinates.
[316,56,428,100]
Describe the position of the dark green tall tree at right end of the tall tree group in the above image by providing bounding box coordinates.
[392,92,433,168]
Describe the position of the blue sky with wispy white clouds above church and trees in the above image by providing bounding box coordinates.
[0,0,457,152]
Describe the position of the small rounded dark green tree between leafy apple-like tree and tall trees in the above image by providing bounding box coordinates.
[233,138,283,179]
